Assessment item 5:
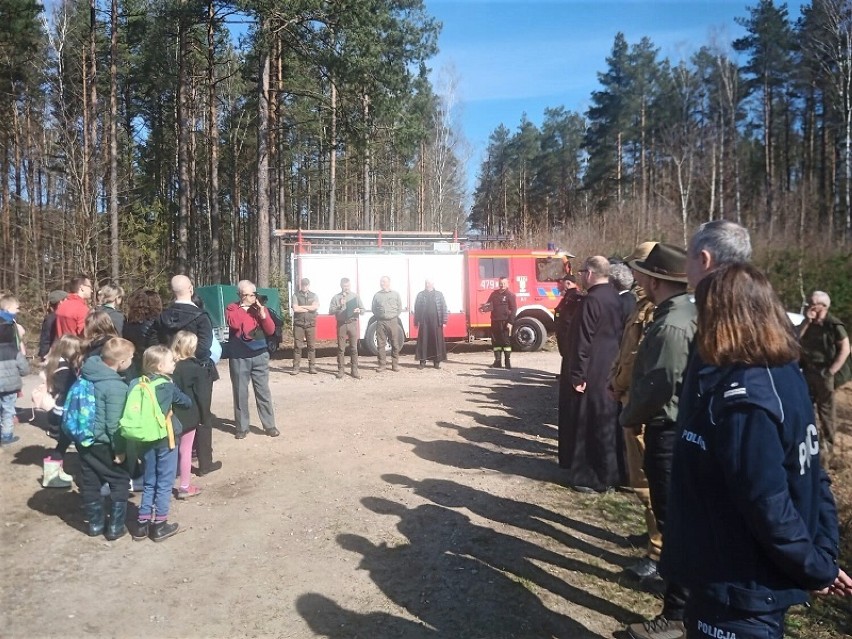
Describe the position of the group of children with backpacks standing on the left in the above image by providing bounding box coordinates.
[0,296,211,541]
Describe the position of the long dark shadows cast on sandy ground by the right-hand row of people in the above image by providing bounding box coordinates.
[296,358,640,639]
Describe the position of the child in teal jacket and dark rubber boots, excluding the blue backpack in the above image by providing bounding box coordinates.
[76,337,134,541]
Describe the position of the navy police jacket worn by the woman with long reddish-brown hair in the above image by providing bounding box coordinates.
[660,354,838,613]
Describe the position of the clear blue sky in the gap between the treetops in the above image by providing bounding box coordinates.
[426,0,806,192]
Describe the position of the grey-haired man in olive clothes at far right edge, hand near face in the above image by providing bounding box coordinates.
[799,291,852,466]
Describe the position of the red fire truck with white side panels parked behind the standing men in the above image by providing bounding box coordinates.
[274,230,574,354]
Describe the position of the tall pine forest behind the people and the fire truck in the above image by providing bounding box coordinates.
[0,0,852,323]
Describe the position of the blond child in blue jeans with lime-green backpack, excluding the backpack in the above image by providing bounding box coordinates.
[133,346,192,541]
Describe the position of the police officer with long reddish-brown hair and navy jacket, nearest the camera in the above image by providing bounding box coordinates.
[664,264,852,639]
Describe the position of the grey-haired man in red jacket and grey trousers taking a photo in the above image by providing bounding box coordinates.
[225,280,281,439]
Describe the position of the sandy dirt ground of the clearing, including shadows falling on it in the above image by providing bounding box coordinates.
[0,344,844,639]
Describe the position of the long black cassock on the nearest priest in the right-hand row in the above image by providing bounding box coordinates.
[559,283,623,490]
